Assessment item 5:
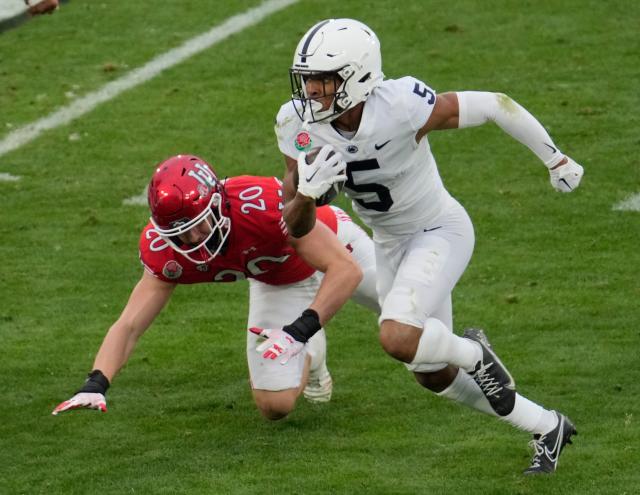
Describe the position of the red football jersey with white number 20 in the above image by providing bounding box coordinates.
[140,175,338,285]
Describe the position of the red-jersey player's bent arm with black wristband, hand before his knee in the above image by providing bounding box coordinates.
[249,222,362,364]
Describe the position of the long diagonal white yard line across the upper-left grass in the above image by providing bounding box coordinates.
[0,0,299,156]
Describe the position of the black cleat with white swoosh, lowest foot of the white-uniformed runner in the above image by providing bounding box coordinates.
[524,411,578,475]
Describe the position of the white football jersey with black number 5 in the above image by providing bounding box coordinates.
[275,77,451,236]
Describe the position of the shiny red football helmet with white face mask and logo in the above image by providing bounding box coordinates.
[148,155,231,263]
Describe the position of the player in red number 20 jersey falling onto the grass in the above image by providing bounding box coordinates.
[53,155,378,419]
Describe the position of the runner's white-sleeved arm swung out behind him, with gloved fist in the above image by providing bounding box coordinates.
[416,91,584,192]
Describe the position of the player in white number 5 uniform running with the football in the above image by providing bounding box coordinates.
[275,19,583,474]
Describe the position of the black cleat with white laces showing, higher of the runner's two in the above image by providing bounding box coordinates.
[462,328,516,416]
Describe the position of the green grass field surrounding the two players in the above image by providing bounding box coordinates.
[0,0,640,495]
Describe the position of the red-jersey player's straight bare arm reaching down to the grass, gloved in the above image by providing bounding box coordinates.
[52,271,175,415]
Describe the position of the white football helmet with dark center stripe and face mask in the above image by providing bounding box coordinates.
[289,19,384,122]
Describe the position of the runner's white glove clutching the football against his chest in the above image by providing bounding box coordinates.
[298,144,347,199]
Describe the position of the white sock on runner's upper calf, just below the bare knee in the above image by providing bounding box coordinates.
[411,318,482,371]
